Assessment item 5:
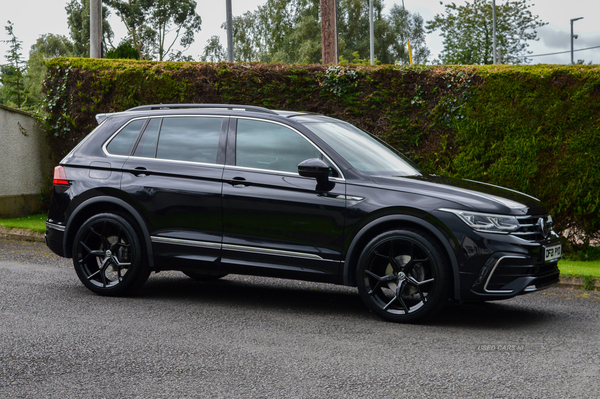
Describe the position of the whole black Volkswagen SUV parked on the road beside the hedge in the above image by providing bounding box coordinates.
[46,104,561,322]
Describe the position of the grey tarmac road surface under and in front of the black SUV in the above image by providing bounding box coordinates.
[0,239,600,398]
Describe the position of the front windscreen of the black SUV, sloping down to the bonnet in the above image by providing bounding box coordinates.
[305,121,422,176]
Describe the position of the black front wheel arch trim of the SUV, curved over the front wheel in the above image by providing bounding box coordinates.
[342,215,460,300]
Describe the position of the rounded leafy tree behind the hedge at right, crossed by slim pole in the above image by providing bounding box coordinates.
[426,0,546,64]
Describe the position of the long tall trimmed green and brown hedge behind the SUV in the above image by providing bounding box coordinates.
[44,58,600,247]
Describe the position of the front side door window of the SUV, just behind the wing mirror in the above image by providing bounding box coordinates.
[235,119,321,173]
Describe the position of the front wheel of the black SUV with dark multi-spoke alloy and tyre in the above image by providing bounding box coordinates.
[357,229,450,323]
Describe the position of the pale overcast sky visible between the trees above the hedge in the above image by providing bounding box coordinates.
[0,0,600,64]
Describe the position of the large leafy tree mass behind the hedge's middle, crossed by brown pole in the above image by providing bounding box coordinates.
[227,0,429,64]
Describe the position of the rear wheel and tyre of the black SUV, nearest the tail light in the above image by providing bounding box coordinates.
[73,213,150,296]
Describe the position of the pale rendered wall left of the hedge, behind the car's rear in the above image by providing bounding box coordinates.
[0,105,52,218]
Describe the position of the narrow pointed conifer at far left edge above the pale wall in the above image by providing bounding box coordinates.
[0,21,27,108]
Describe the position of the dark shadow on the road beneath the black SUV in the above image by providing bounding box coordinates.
[134,272,559,329]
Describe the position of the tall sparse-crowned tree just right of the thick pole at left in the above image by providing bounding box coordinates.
[104,0,202,61]
